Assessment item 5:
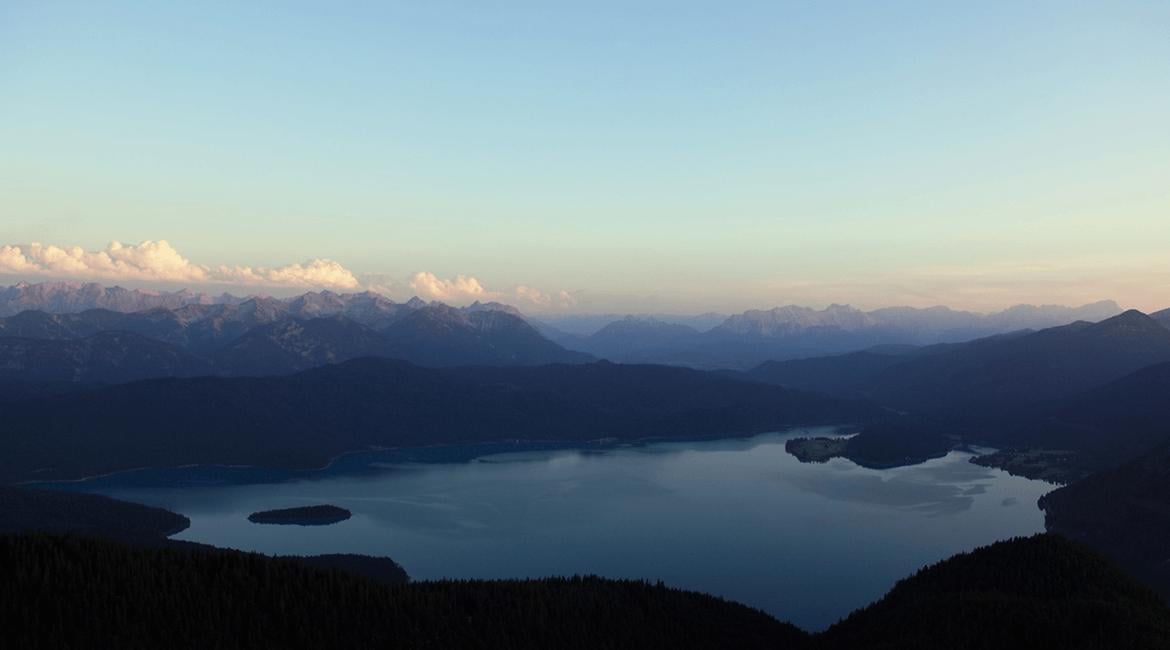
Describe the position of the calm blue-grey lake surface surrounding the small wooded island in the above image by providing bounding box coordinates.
[64,429,1052,630]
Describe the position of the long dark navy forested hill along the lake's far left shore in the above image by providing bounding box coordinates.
[0,359,878,482]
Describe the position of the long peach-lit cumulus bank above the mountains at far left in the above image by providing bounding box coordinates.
[0,240,359,289]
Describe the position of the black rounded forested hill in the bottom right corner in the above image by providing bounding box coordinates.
[820,535,1170,650]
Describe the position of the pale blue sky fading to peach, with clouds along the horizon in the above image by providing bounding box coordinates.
[0,0,1170,312]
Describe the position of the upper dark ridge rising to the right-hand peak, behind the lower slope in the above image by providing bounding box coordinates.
[748,310,1170,422]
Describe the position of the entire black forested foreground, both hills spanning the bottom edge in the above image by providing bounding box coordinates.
[0,534,1170,650]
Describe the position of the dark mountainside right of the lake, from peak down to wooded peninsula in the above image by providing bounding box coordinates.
[746,311,1170,480]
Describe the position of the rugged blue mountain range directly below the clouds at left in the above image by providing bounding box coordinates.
[0,291,592,382]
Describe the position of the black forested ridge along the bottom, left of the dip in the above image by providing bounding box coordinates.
[0,535,807,650]
